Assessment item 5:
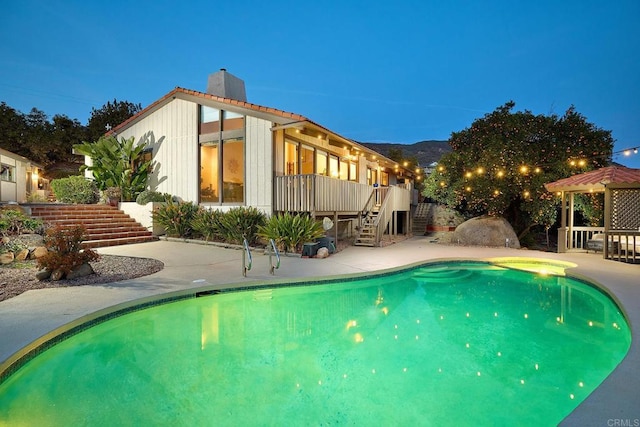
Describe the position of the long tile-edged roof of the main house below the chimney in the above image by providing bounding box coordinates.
[107,87,413,175]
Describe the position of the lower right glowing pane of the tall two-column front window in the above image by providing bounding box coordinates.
[222,138,244,203]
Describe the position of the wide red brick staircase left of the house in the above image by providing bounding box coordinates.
[31,204,157,248]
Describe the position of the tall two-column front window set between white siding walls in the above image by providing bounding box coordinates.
[200,106,244,203]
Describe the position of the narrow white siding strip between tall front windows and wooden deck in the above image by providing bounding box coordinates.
[245,116,273,214]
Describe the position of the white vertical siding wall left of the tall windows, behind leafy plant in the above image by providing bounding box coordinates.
[118,99,199,202]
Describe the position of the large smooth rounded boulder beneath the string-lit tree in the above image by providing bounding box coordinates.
[453,216,520,249]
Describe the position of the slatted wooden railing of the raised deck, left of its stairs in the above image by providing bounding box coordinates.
[273,175,373,213]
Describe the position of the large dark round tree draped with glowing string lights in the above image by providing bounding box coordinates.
[423,102,613,238]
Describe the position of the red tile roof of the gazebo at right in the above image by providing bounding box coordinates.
[544,166,640,192]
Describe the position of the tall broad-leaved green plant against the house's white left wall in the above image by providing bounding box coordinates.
[74,136,153,201]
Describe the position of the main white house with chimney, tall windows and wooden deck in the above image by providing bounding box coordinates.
[92,69,419,245]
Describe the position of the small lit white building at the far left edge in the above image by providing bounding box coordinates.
[0,148,43,203]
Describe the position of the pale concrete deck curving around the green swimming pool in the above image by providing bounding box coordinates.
[0,236,640,426]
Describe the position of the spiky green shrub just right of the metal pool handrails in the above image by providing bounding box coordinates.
[258,212,324,252]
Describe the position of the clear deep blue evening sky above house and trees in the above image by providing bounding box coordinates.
[0,0,640,168]
